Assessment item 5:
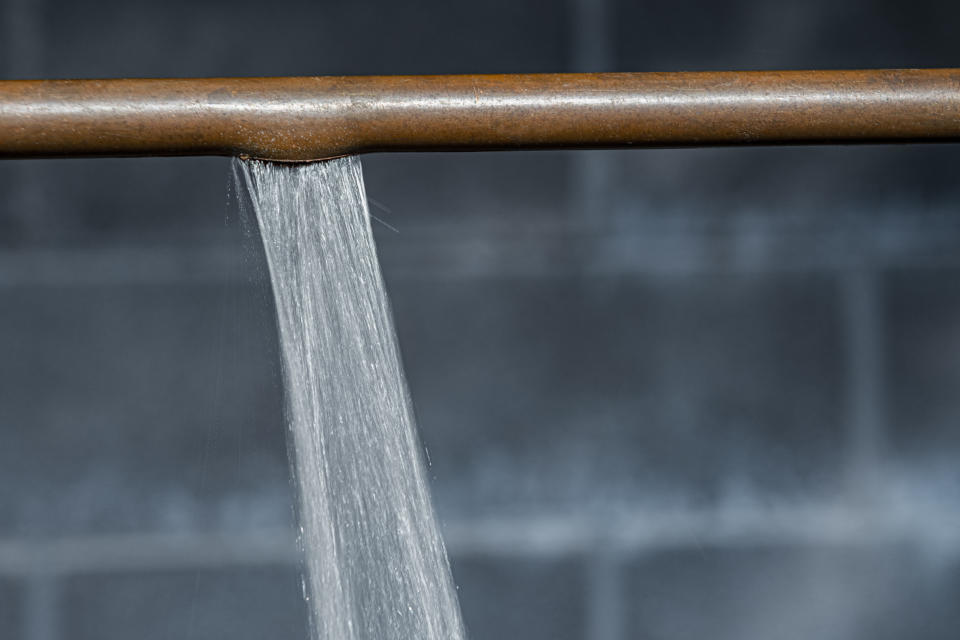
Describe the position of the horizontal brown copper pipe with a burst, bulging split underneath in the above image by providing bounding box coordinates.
[0,69,960,161]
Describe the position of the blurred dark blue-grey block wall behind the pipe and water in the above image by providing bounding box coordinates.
[0,0,960,640]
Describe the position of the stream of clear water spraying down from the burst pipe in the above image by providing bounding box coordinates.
[235,157,464,640]
